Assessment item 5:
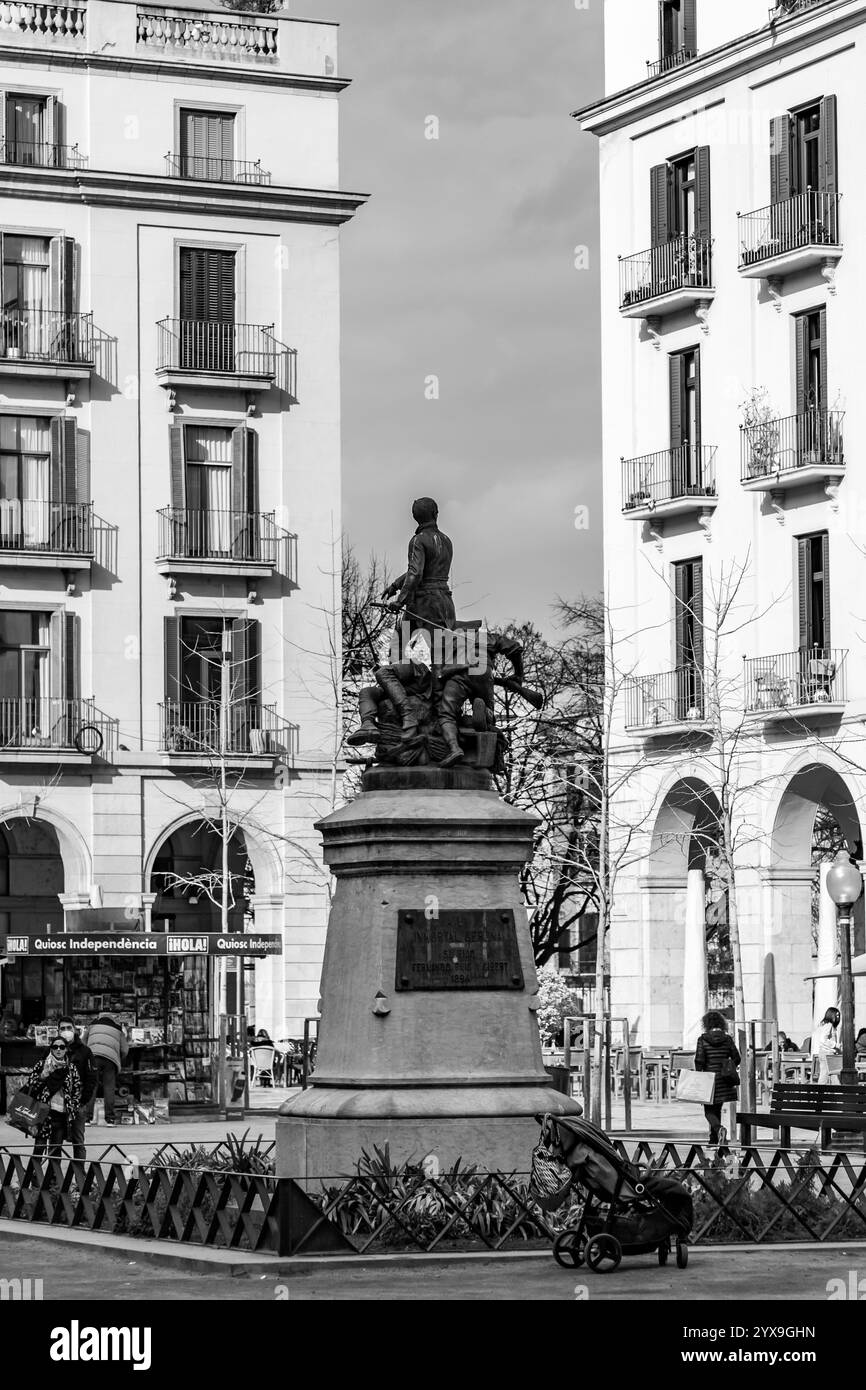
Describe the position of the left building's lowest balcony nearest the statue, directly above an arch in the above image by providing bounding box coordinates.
[160,699,295,762]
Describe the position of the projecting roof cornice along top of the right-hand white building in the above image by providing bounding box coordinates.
[571,0,866,136]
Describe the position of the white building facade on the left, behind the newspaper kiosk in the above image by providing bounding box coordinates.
[0,0,363,1037]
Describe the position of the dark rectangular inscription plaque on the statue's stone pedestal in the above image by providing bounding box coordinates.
[395,908,524,991]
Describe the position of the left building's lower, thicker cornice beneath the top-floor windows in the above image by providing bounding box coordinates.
[0,164,370,227]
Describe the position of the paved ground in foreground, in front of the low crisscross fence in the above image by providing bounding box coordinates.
[0,1226,866,1302]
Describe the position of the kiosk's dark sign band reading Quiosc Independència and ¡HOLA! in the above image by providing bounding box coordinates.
[6,930,282,960]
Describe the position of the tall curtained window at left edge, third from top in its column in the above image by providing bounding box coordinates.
[0,416,51,549]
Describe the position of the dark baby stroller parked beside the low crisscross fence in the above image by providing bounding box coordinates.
[538,1115,695,1273]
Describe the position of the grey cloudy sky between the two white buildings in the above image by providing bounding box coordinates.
[292,0,603,627]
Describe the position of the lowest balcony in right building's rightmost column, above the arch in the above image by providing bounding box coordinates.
[744,646,848,723]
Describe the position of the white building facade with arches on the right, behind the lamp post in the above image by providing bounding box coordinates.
[578,0,866,1045]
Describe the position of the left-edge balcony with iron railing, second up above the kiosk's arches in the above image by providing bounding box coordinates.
[0,498,95,570]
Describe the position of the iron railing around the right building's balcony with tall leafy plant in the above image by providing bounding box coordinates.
[740,407,845,482]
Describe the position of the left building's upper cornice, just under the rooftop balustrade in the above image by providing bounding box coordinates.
[0,43,352,96]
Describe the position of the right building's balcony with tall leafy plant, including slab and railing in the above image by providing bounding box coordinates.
[740,407,845,492]
